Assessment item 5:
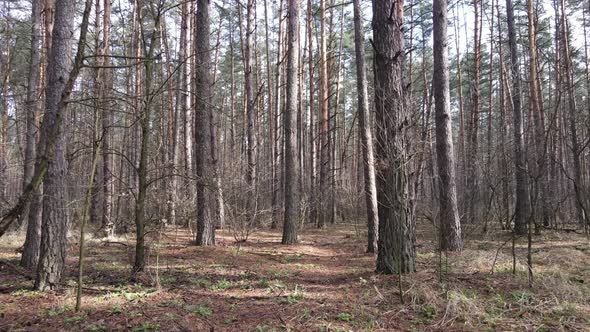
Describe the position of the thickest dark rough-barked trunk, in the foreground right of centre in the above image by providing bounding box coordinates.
[373,0,416,273]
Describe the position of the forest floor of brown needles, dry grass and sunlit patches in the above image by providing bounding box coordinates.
[0,223,590,332]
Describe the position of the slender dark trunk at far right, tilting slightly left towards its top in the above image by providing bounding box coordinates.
[506,0,530,235]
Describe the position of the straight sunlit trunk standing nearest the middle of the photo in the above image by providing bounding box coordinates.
[282,0,299,244]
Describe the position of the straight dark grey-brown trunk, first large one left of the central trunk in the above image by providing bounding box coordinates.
[195,0,215,246]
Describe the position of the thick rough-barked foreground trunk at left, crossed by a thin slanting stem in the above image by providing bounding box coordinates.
[36,0,92,290]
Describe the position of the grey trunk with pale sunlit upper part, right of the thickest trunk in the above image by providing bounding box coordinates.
[432,0,463,250]
